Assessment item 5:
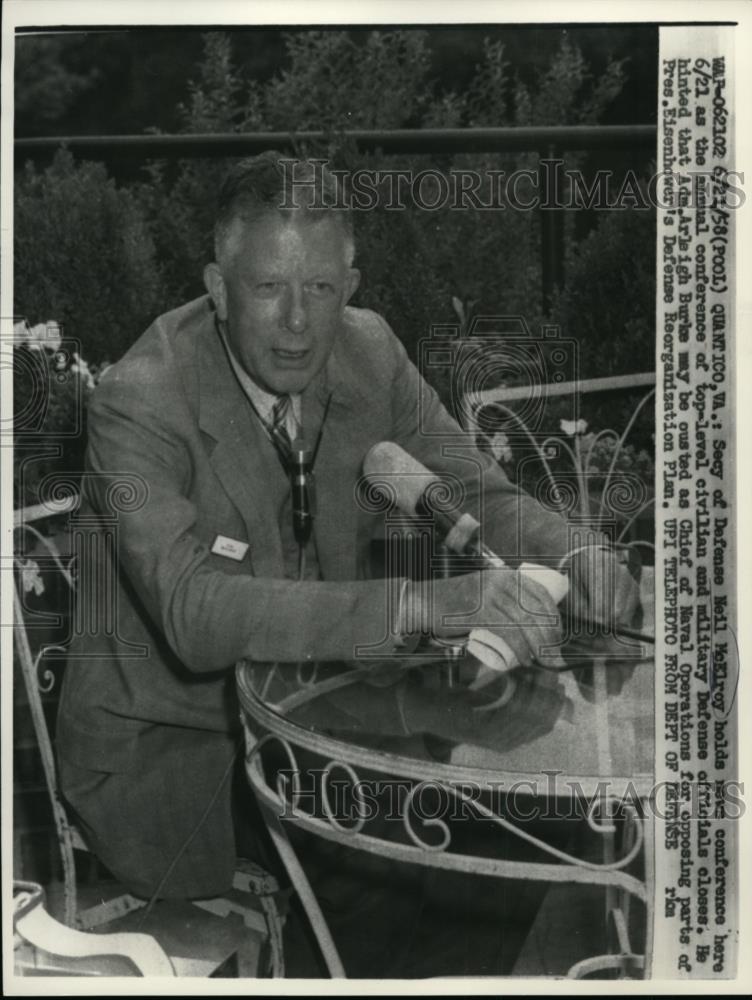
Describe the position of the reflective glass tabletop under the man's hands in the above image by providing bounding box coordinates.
[241,577,654,796]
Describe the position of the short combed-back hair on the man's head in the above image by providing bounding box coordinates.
[214,150,355,267]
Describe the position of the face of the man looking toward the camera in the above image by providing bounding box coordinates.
[204,210,359,395]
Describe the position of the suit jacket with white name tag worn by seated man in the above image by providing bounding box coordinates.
[58,297,567,895]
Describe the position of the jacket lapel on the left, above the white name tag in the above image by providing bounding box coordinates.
[196,322,285,577]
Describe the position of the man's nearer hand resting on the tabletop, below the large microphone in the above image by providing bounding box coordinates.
[402,567,563,667]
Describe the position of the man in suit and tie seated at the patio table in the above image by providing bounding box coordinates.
[57,154,636,916]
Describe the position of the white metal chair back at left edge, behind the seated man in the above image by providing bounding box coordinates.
[13,495,85,926]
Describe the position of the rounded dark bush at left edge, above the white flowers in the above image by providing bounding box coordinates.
[14,151,163,362]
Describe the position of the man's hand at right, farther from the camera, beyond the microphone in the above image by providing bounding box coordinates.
[570,545,640,631]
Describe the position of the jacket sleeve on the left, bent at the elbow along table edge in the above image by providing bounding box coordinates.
[85,376,406,672]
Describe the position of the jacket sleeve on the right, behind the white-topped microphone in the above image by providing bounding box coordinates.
[382,320,569,565]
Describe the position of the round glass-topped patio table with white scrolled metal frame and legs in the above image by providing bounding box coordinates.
[237,579,654,978]
